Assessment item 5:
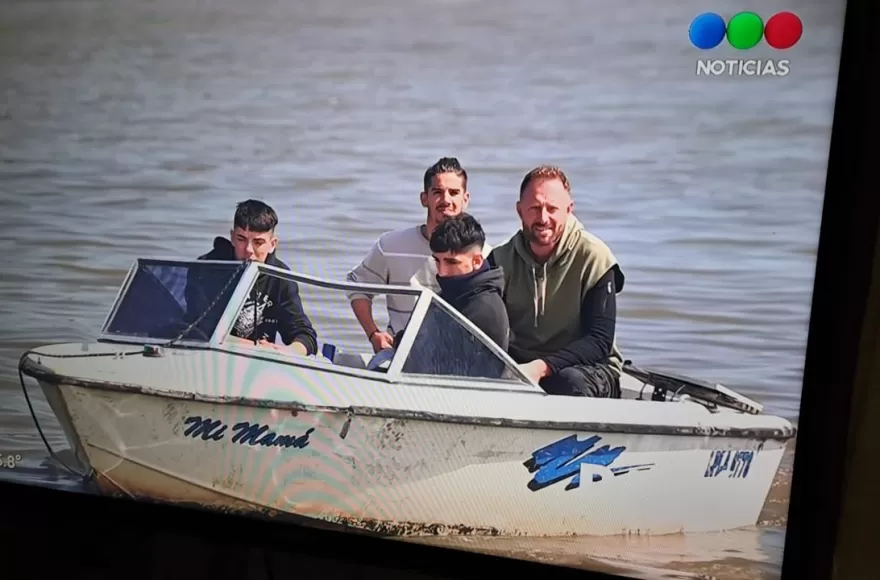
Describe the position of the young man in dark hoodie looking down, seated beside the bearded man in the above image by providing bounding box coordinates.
[430,213,510,352]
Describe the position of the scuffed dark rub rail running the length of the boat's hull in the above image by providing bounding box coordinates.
[19,349,797,442]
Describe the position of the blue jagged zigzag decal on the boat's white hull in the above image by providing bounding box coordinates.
[523,435,654,491]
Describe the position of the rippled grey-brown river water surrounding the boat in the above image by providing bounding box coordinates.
[0,0,844,577]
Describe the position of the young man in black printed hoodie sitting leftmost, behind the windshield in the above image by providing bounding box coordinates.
[186,199,318,355]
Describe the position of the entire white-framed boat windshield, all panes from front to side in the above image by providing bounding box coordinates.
[102,259,526,383]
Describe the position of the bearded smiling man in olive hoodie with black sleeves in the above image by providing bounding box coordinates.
[489,166,624,398]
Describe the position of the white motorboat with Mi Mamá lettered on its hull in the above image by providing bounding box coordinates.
[20,259,795,536]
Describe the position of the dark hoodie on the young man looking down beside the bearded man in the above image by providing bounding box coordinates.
[437,262,510,351]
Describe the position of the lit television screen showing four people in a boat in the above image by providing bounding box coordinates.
[0,0,845,579]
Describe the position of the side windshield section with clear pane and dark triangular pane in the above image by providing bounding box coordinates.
[237,264,527,383]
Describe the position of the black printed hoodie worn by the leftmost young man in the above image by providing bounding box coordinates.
[186,237,318,354]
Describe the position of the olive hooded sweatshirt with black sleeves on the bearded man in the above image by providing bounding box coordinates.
[489,215,624,374]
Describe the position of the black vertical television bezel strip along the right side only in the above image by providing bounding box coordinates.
[782,0,880,579]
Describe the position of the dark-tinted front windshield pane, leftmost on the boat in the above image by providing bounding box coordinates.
[103,259,245,343]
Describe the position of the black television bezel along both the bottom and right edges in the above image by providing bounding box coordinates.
[0,0,880,580]
